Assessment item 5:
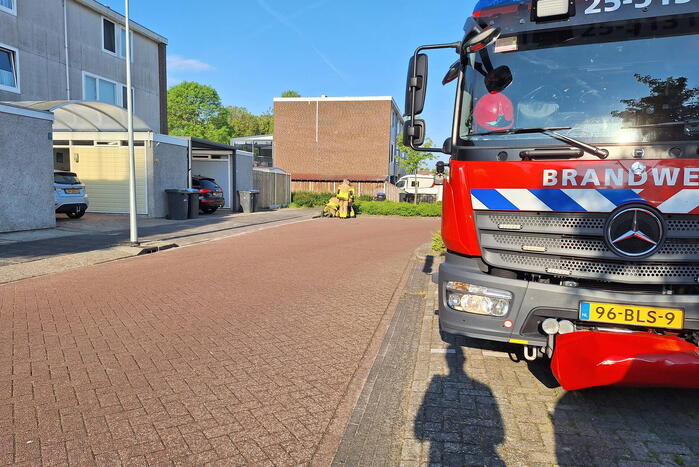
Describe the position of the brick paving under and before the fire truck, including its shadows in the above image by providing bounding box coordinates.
[335,256,699,466]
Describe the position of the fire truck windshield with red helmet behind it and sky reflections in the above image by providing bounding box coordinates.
[460,15,699,146]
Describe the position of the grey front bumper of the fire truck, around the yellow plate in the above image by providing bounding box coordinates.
[433,253,699,349]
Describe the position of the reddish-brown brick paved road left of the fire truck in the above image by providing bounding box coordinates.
[0,218,437,465]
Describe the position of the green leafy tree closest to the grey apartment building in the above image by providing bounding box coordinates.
[167,81,231,144]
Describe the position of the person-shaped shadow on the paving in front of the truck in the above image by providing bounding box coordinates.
[414,345,505,465]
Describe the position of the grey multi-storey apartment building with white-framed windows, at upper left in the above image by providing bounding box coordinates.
[0,0,167,133]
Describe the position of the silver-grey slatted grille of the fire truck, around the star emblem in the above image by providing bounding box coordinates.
[476,212,699,284]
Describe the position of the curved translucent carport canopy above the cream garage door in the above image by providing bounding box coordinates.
[6,101,153,132]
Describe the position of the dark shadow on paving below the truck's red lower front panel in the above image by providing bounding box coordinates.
[552,387,699,465]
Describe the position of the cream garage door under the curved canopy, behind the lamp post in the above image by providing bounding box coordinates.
[71,147,148,214]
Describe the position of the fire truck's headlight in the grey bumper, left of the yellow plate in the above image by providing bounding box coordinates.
[447,282,513,317]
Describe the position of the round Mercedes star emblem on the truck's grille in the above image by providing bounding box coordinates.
[605,205,665,258]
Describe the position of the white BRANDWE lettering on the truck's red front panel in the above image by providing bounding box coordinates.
[544,167,699,187]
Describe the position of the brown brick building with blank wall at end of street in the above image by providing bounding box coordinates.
[274,97,403,194]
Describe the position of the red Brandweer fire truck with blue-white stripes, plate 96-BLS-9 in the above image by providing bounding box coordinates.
[404,0,699,389]
